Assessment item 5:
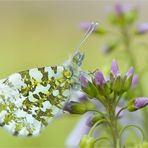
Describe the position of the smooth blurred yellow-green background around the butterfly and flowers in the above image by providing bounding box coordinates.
[0,0,148,148]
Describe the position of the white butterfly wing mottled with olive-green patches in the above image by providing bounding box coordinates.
[0,66,72,136]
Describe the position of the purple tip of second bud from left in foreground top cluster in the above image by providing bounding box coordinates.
[94,70,105,87]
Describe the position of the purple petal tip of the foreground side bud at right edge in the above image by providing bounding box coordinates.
[134,97,148,109]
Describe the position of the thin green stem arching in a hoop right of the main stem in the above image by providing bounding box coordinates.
[119,124,144,146]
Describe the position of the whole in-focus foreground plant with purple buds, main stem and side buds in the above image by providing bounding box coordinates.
[64,60,148,148]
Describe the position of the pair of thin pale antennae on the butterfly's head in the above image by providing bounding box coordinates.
[75,22,98,52]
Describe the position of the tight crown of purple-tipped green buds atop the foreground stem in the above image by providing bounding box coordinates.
[80,59,134,98]
